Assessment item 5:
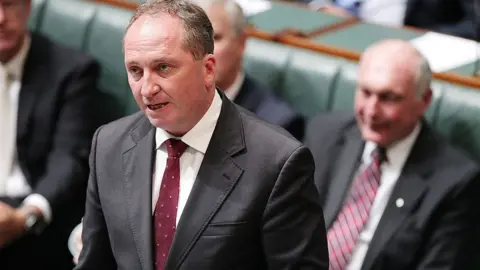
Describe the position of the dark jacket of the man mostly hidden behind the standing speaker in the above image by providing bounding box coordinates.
[234,75,305,140]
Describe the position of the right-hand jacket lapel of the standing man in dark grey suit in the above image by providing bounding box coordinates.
[165,94,245,270]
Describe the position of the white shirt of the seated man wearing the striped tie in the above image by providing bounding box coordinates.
[347,123,421,270]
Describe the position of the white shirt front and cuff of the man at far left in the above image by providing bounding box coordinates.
[0,36,52,222]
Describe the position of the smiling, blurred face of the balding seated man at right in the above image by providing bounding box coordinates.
[355,56,431,147]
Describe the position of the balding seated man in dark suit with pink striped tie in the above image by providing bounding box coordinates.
[306,40,480,270]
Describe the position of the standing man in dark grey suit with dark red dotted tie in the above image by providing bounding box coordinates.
[76,0,328,270]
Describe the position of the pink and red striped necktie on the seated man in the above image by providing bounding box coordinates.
[327,148,386,270]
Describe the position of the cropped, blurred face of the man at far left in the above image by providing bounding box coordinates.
[0,0,30,62]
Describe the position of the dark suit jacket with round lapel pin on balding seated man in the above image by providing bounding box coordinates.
[306,110,480,270]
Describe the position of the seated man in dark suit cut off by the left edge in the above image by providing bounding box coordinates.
[0,0,99,270]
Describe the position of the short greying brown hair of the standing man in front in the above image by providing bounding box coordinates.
[125,0,214,60]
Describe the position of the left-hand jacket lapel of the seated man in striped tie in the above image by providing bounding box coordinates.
[324,127,364,228]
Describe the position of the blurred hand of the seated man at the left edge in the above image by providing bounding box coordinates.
[0,202,27,248]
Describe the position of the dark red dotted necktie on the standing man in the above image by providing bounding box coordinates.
[153,139,187,270]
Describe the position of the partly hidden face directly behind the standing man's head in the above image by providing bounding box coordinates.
[206,5,246,90]
